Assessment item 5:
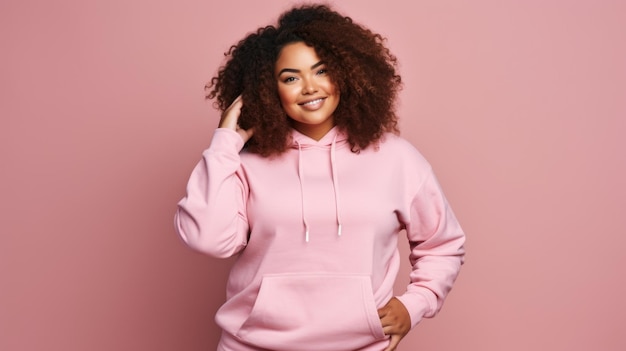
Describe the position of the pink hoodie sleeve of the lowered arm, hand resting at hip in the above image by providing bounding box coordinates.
[398,171,465,327]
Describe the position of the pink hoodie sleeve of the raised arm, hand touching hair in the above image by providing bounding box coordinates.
[174,128,249,257]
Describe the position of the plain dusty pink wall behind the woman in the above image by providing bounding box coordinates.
[0,0,626,351]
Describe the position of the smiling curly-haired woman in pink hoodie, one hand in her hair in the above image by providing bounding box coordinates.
[176,5,465,351]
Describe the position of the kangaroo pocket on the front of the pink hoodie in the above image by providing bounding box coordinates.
[237,274,385,351]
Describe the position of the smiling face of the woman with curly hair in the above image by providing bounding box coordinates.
[275,42,339,140]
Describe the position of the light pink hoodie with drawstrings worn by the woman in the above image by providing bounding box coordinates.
[175,127,465,351]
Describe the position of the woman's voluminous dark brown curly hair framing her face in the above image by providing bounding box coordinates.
[206,5,402,156]
